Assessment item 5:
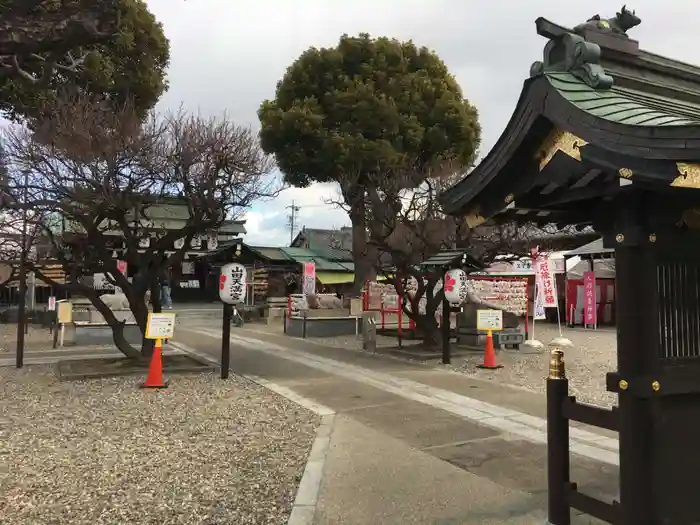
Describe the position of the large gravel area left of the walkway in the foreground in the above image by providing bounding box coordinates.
[0,366,319,525]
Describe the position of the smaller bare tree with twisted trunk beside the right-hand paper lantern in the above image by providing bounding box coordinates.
[352,166,566,346]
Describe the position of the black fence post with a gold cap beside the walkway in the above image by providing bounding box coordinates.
[547,349,571,525]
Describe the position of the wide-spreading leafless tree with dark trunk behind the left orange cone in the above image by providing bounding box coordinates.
[5,94,280,358]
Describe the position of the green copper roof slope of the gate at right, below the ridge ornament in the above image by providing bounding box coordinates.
[546,73,700,126]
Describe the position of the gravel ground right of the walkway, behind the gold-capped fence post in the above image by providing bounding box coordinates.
[455,324,617,407]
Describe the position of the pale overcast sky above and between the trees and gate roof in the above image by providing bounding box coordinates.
[147,0,700,246]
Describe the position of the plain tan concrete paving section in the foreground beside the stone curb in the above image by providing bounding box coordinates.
[314,416,548,525]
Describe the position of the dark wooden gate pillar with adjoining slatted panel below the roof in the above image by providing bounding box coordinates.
[604,194,700,525]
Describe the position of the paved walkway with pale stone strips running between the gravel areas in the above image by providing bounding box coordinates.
[171,319,617,525]
